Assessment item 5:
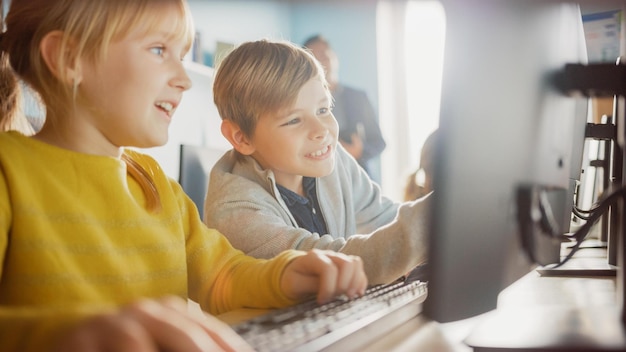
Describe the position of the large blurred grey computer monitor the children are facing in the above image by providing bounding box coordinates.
[424,0,588,322]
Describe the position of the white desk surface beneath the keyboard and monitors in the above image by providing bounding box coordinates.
[219,249,626,352]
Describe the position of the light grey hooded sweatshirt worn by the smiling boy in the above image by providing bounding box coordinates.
[204,147,432,284]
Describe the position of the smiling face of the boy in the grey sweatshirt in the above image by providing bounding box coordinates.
[250,78,339,192]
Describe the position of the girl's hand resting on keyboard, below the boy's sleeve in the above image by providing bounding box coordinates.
[281,249,367,303]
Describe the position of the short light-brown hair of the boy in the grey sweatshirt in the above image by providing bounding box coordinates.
[213,40,330,137]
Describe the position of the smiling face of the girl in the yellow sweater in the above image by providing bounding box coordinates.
[69,6,191,155]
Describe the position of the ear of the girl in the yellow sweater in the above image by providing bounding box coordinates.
[39,31,82,85]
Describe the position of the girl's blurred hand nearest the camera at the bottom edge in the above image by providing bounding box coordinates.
[56,297,252,352]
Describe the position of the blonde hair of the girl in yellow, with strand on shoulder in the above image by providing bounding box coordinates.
[0,0,194,210]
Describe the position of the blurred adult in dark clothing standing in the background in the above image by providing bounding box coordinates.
[303,34,386,181]
